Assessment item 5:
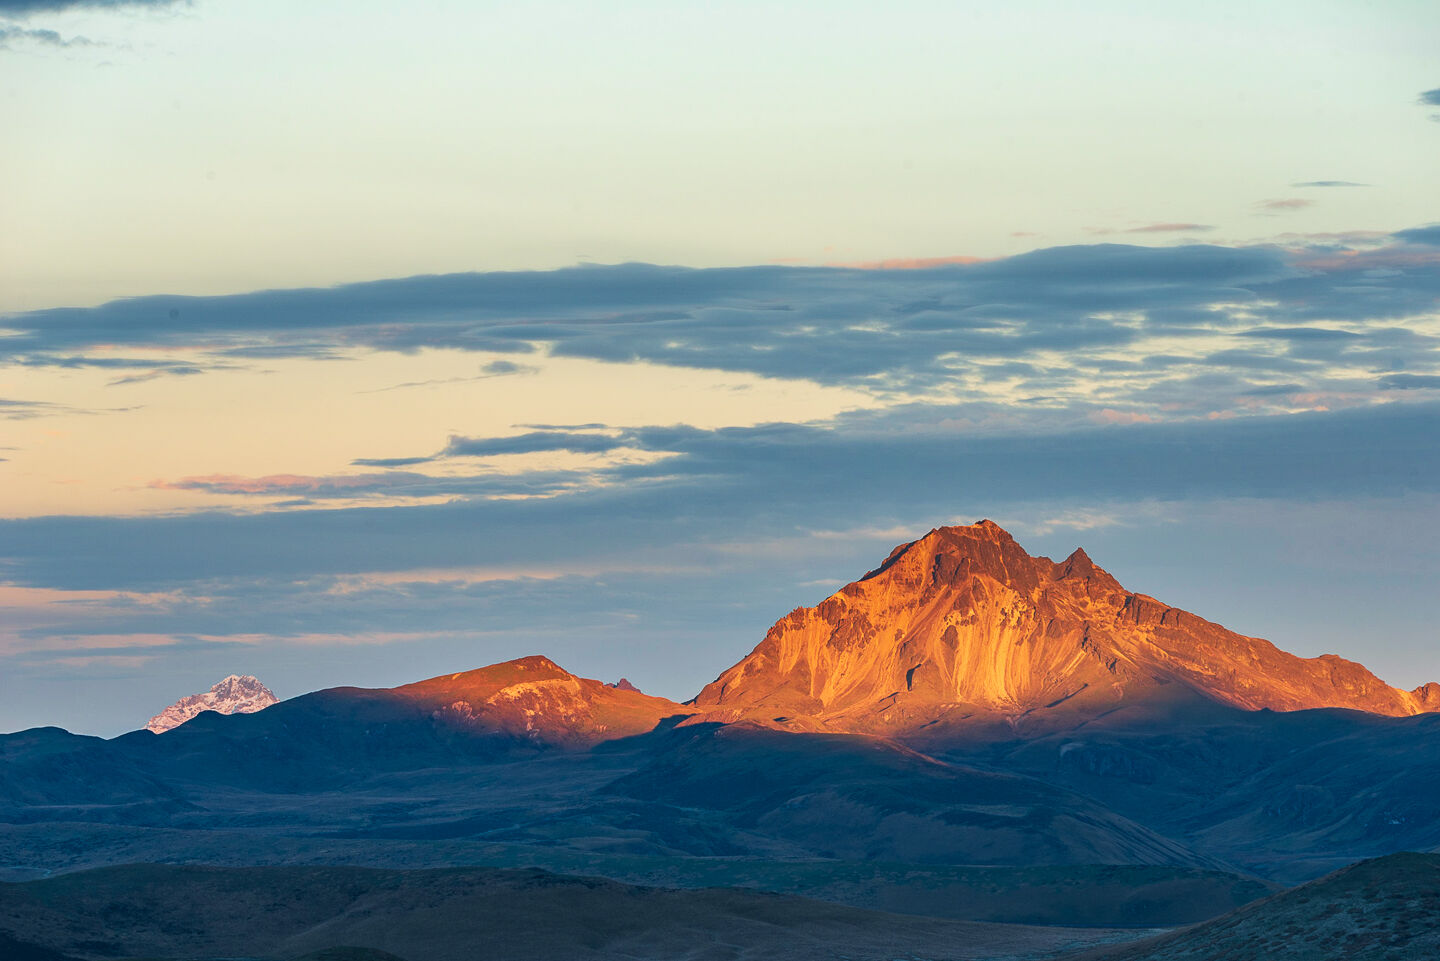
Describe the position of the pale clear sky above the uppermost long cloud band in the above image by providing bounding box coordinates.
[8,0,1440,310]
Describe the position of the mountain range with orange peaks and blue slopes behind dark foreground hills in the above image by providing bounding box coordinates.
[0,522,1440,961]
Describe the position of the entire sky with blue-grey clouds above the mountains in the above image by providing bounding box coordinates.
[0,0,1440,736]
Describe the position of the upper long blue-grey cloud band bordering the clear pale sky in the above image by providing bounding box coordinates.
[0,237,1440,417]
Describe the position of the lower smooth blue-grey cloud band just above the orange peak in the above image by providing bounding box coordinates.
[0,403,1440,589]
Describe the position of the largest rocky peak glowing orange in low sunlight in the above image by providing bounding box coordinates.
[694,520,1440,733]
